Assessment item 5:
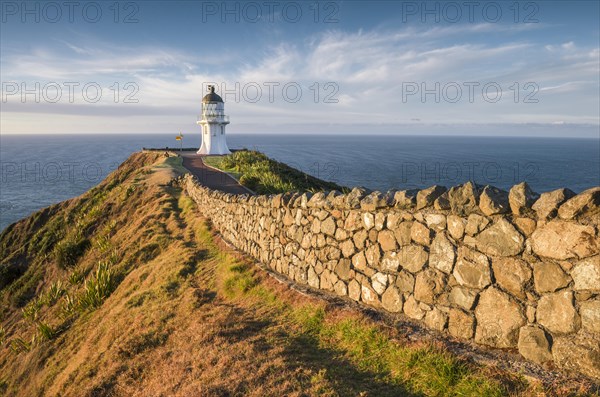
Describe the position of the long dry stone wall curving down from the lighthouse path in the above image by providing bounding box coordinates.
[181,175,600,379]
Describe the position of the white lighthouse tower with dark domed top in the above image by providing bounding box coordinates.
[196,85,231,154]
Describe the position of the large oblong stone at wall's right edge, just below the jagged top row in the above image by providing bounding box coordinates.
[531,220,598,260]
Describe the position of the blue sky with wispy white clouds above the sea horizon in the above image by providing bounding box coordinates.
[0,1,600,137]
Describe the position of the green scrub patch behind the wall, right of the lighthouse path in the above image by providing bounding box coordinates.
[204,150,345,194]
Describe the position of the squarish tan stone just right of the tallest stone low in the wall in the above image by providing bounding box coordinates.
[536,291,578,334]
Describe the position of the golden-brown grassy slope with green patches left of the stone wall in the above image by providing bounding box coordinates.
[0,154,592,396]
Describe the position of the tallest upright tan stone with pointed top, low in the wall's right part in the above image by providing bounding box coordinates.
[475,287,526,348]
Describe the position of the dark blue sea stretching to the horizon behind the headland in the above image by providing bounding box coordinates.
[0,134,600,230]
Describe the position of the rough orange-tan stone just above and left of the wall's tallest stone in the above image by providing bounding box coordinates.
[453,246,492,289]
